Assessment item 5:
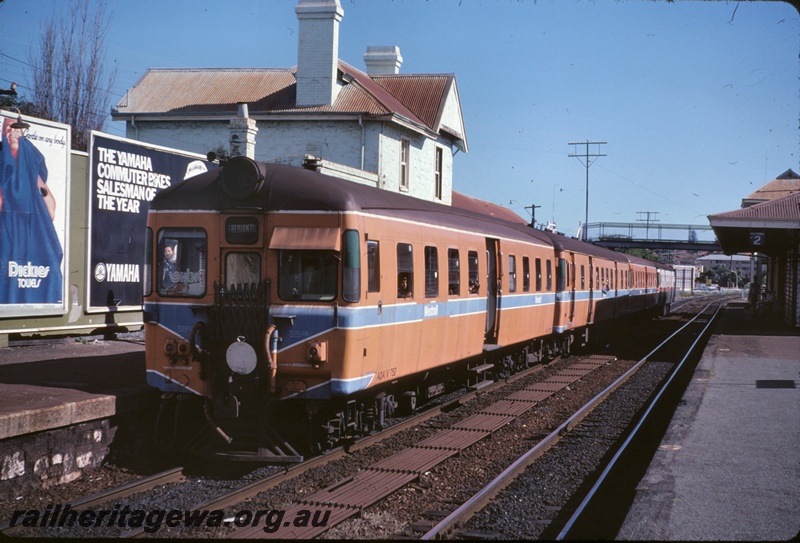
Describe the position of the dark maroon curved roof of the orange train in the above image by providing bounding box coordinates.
[150,157,552,246]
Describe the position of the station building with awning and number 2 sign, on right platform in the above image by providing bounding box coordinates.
[708,169,800,327]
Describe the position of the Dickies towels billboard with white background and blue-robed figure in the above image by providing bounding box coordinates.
[0,111,71,317]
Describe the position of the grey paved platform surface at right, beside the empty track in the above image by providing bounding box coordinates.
[617,304,800,541]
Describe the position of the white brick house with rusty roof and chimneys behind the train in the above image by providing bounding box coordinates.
[112,0,468,204]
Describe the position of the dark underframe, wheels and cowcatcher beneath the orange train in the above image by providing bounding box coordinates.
[156,328,588,463]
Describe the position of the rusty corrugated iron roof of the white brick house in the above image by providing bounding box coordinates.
[111,60,467,151]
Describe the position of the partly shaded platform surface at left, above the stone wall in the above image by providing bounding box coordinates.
[0,334,156,439]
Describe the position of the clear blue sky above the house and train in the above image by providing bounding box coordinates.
[0,0,800,235]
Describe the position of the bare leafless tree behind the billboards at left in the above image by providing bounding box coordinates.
[30,0,117,151]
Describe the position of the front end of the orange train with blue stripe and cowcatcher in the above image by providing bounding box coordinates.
[145,158,361,462]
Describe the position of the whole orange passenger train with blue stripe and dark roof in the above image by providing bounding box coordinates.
[144,157,674,462]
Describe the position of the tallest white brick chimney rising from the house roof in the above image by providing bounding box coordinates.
[294,0,344,106]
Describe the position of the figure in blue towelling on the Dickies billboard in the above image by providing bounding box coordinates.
[0,117,64,304]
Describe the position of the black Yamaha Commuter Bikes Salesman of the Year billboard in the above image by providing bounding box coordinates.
[86,132,217,312]
